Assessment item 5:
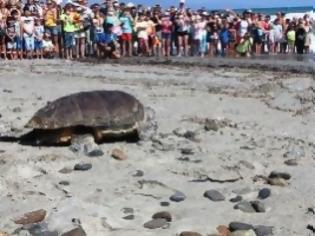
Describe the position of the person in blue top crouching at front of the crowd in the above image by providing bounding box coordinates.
[98,24,120,59]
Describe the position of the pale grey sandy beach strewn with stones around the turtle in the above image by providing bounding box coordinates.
[0,59,315,236]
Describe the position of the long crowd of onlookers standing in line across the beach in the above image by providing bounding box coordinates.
[0,0,314,60]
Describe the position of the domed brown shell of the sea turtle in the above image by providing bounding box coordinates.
[26,90,144,130]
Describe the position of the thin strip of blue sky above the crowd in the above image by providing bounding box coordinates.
[133,0,315,9]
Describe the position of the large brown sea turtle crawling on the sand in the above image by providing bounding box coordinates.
[21,90,157,145]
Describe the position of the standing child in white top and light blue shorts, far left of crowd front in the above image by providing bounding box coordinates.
[21,7,35,59]
